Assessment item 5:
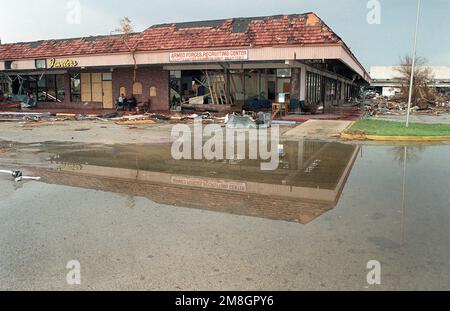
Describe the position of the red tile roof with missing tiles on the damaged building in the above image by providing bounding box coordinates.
[0,13,342,60]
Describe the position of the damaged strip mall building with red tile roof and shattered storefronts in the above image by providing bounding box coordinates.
[0,13,370,112]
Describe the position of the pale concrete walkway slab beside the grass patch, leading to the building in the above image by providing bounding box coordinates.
[284,120,353,139]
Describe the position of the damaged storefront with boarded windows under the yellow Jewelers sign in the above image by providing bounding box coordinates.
[3,57,168,110]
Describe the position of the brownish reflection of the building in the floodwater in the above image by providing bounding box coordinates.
[32,141,359,224]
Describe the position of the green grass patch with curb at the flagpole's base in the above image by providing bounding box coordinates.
[347,119,450,136]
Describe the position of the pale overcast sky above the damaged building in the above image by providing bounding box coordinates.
[0,0,450,69]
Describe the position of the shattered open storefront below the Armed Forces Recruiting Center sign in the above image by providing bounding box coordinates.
[164,50,366,113]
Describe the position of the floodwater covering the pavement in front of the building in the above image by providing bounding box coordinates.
[0,141,450,290]
